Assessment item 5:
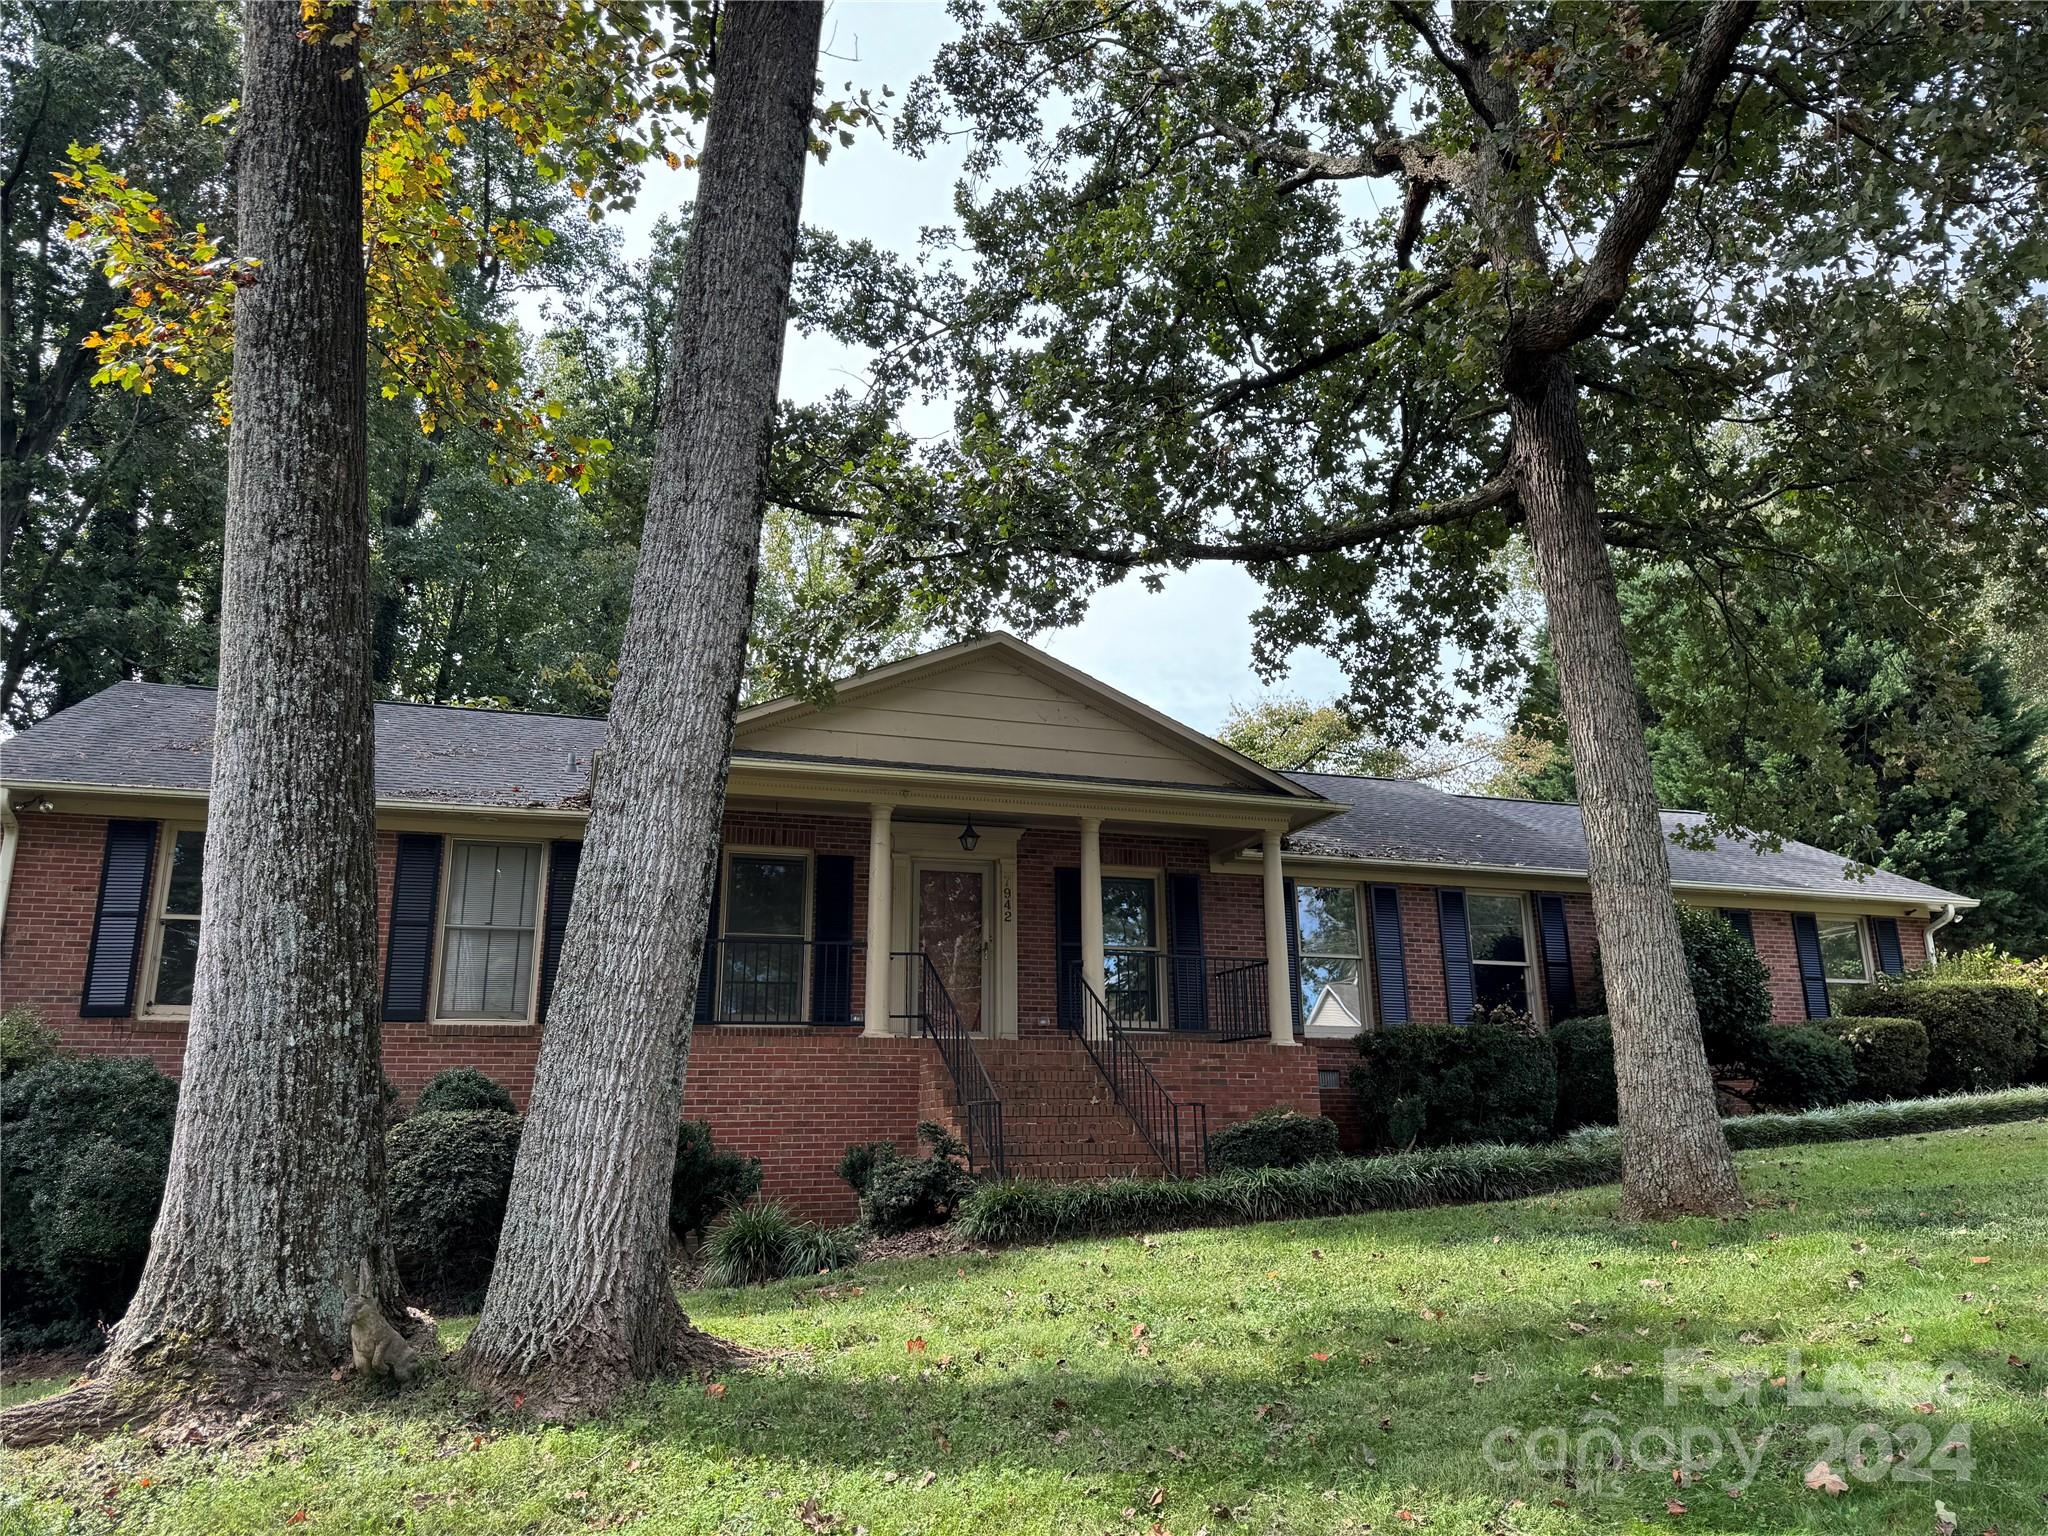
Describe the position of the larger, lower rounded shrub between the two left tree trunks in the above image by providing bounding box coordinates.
[385,1110,520,1307]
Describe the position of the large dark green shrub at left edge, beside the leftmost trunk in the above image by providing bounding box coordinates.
[0,1057,178,1348]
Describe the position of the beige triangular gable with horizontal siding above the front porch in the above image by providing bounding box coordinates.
[733,635,1313,799]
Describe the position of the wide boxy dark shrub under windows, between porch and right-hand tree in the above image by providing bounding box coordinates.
[1352,1024,1556,1147]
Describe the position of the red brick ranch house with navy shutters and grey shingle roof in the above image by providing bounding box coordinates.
[0,635,1974,1219]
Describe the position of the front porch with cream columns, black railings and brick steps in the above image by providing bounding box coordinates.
[698,786,1317,1178]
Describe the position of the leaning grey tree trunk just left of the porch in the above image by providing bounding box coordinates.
[465,0,823,1415]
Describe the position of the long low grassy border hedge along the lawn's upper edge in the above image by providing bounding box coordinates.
[958,1087,2048,1243]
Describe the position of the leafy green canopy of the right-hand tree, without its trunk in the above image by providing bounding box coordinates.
[802,0,2048,770]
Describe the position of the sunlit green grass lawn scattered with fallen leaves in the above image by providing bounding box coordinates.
[0,1122,2048,1536]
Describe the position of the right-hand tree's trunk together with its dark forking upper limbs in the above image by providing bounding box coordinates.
[1452,0,1757,1219]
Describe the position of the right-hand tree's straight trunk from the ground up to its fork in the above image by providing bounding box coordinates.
[1509,354,1741,1217]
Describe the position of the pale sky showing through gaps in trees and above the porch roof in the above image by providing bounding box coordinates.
[573,0,1343,729]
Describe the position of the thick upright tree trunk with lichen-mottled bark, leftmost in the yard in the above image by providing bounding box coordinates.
[12,0,389,1441]
